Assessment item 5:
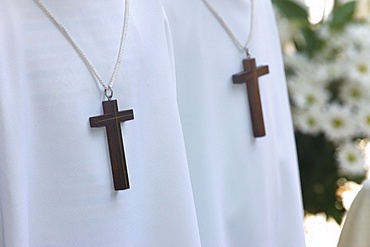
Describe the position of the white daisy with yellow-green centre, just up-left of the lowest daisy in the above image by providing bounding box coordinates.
[322,104,356,142]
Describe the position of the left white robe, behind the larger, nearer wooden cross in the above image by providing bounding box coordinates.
[0,0,200,247]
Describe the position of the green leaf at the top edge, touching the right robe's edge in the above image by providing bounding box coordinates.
[272,0,308,21]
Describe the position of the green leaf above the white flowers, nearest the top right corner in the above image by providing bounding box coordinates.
[330,2,356,29]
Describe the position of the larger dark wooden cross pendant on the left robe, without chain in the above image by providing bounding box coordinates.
[90,100,134,190]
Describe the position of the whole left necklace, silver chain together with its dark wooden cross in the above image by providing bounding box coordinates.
[34,0,134,190]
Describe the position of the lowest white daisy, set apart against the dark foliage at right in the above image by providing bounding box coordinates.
[337,142,366,176]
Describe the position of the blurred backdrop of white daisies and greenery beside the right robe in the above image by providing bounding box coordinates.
[273,0,370,247]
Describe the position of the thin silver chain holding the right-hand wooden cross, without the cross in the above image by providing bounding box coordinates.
[203,0,254,57]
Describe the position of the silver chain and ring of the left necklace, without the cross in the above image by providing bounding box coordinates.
[34,0,130,100]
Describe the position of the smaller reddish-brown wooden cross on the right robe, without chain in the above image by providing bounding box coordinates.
[233,58,269,137]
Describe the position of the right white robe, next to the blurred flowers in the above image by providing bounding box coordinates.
[164,0,305,247]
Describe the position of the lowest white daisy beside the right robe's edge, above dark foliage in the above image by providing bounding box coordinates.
[293,107,323,135]
